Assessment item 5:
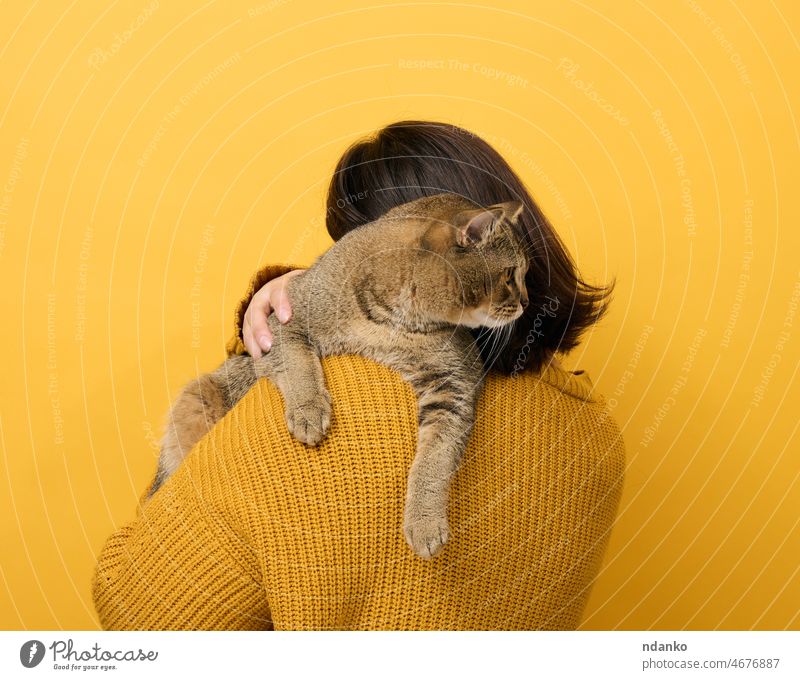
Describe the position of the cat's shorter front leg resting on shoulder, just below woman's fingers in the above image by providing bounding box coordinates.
[255,324,331,446]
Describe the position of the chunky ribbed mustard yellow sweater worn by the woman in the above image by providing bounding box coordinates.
[93,267,625,630]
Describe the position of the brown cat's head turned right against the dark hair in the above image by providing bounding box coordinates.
[422,194,528,328]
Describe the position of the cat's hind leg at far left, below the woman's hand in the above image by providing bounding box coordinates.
[149,375,228,496]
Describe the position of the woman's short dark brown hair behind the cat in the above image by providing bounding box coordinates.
[326,121,614,374]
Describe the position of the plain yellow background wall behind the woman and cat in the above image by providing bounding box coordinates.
[0,0,800,629]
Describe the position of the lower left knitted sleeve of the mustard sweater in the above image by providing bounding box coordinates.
[92,465,272,630]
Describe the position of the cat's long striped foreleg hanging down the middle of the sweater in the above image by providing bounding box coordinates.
[394,340,483,559]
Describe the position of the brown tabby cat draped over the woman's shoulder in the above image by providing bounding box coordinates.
[150,194,528,559]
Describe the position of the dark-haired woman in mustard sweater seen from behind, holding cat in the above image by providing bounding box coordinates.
[94,121,625,629]
